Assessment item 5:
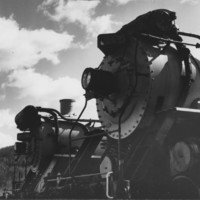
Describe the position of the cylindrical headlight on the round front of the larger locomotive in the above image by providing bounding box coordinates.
[81,68,117,98]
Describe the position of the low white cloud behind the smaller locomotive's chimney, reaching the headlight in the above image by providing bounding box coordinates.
[4,69,97,120]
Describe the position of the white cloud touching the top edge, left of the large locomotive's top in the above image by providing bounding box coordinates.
[39,0,120,36]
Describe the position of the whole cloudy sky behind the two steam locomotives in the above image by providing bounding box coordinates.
[0,0,200,148]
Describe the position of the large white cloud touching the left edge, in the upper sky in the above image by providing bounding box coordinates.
[0,18,73,71]
